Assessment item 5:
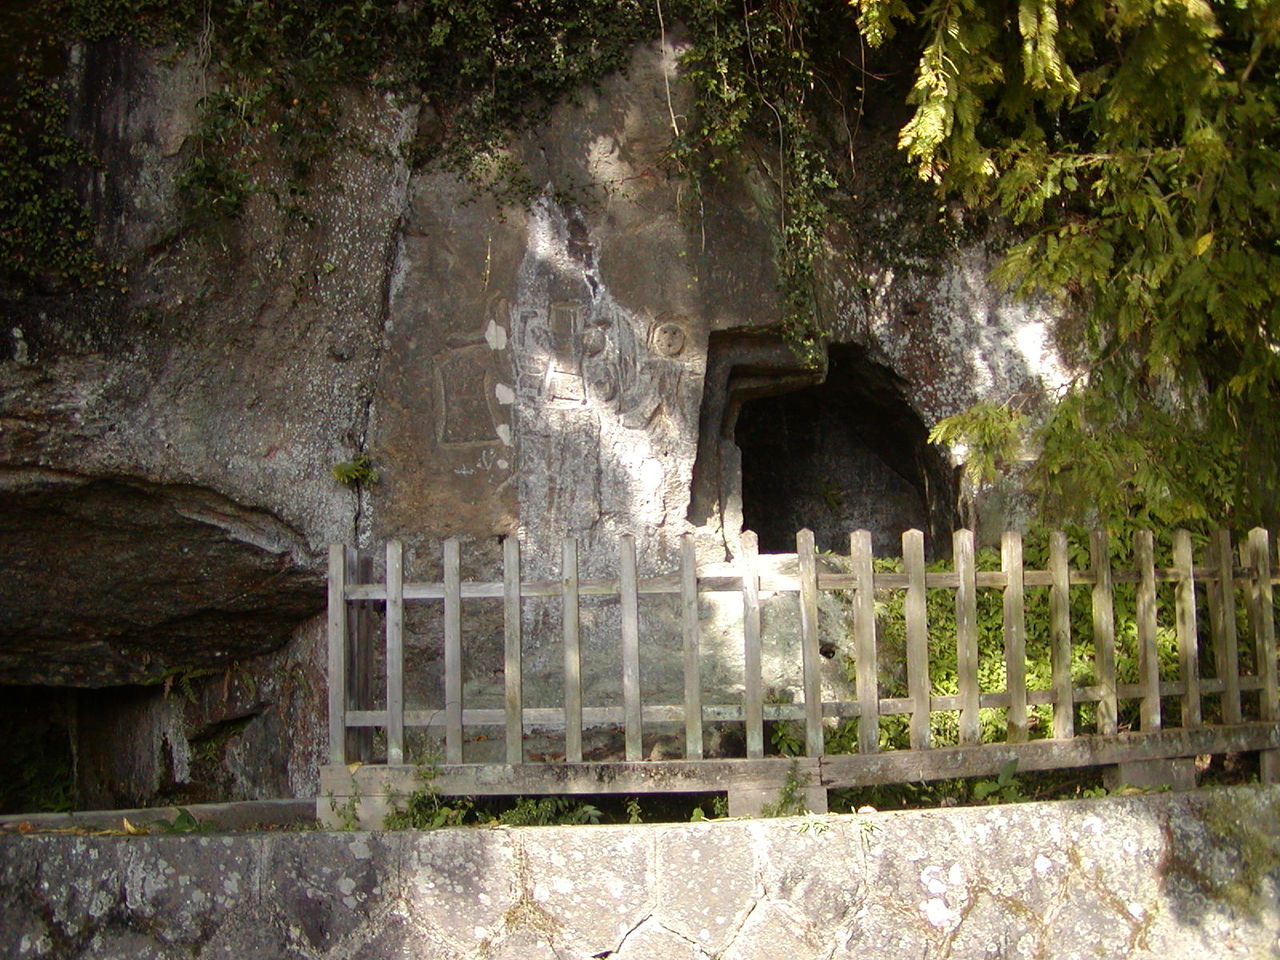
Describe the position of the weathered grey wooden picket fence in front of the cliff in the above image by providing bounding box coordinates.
[317,529,1280,822]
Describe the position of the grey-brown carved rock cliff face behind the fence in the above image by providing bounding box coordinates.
[0,33,1062,803]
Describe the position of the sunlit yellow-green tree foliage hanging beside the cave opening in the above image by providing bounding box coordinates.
[856,0,1280,526]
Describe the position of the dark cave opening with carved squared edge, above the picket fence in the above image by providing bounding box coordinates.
[690,333,956,556]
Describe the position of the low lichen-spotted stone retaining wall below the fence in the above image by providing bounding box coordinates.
[0,787,1280,960]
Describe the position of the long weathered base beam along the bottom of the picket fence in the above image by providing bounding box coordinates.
[320,723,1280,797]
